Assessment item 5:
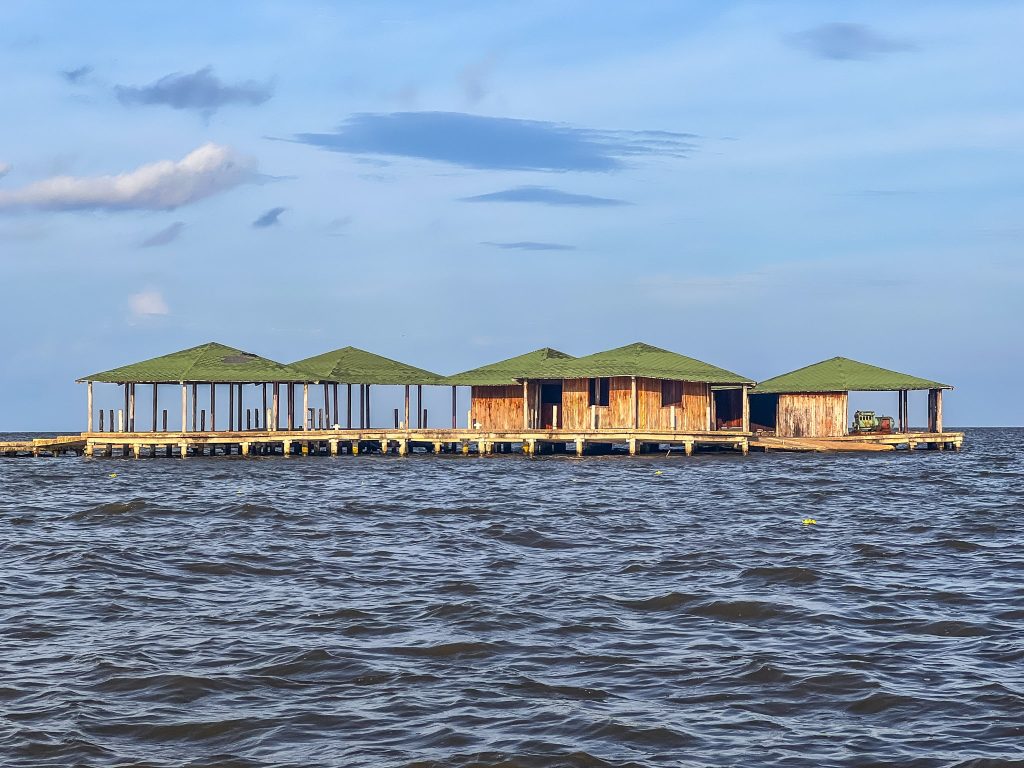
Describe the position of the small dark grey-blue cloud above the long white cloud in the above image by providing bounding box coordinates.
[114,67,273,115]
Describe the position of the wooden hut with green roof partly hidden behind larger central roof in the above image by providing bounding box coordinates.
[445,347,573,432]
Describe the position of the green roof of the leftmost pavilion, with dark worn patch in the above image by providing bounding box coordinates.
[79,341,314,384]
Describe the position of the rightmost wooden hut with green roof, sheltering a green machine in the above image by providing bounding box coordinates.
[751,357,952,437]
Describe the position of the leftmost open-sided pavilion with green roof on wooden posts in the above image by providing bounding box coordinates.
[78,341,314,432]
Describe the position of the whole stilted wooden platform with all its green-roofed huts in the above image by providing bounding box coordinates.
[0,342,964,459]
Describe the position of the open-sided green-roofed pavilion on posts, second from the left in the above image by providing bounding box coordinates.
[291,346,444,429]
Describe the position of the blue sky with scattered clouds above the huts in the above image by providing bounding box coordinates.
[0,0,1024,429]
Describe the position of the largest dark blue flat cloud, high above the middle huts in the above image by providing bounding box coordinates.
[295,112,695,172]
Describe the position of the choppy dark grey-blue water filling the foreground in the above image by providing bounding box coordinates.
[0,430,1024,768]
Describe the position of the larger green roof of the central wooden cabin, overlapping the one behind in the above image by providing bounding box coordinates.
[560,342,754,384]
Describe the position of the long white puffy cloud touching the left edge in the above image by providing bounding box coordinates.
[0,143,258,211]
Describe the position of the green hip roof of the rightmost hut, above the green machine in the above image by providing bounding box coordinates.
[751,357,952,394]
